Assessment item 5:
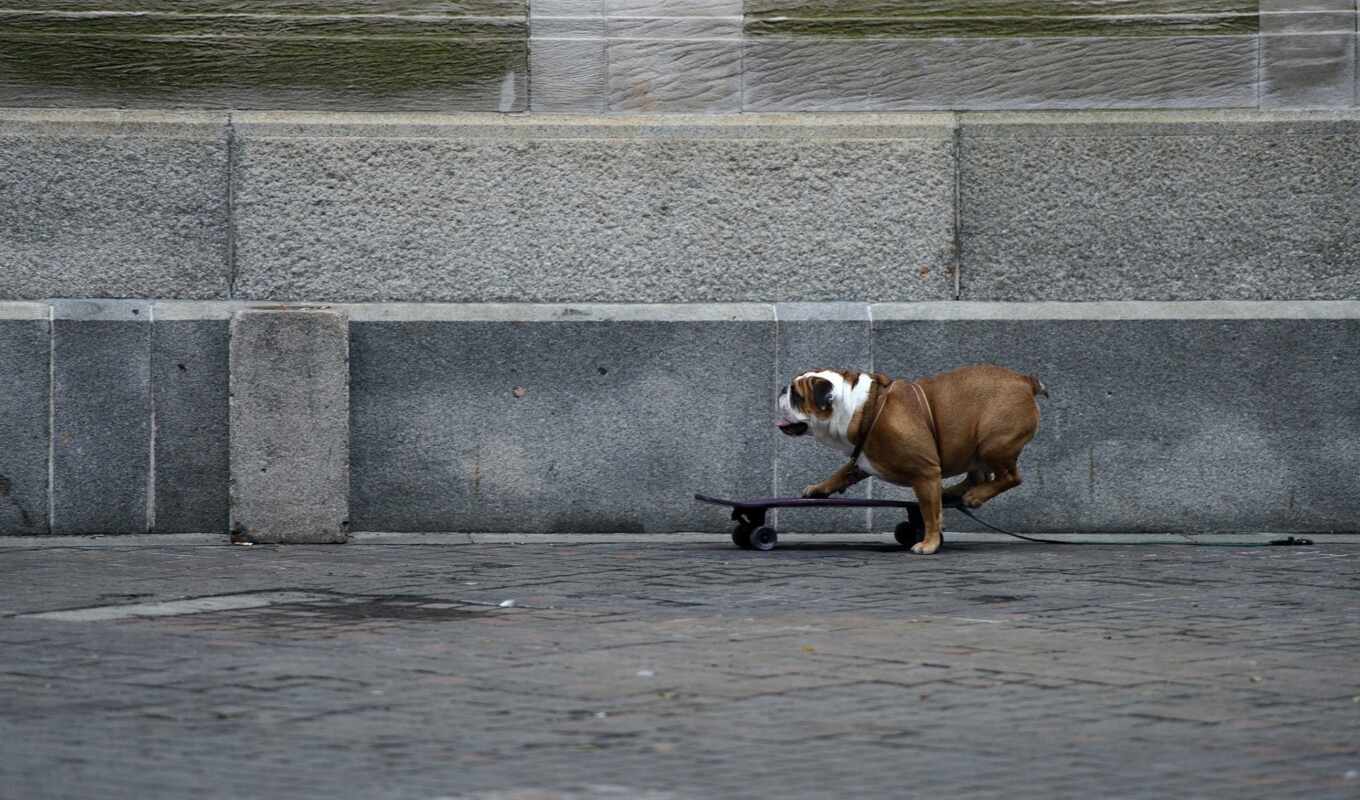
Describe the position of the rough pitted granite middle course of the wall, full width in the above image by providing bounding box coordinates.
[0,112,1360,303]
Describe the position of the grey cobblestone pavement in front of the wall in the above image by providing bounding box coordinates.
[0,540,1360,800]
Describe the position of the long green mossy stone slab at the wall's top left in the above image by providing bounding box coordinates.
[0,6,528,112]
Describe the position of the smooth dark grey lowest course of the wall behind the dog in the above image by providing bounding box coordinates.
[0,301,1360,540]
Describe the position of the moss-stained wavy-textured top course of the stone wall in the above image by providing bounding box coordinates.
[0,0,1357,114]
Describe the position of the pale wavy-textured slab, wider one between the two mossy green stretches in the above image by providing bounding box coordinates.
[607,39,743,113]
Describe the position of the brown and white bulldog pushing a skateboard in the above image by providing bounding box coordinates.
[777,365,1049,555]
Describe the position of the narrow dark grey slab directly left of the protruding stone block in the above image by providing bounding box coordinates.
[151,318,230,533]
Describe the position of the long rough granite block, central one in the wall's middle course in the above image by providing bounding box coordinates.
[235,117,955,302]
